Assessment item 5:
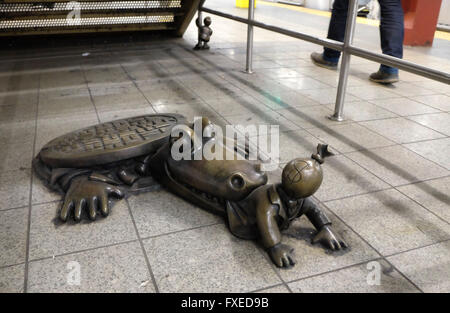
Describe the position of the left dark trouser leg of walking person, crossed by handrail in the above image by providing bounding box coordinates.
[323,0,348,63]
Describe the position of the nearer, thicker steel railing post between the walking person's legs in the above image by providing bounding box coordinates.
[330,0,358,122]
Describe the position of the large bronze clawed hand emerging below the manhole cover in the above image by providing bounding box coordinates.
[59,176,124,222]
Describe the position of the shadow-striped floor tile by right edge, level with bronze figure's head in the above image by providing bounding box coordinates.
[347,146,449,186]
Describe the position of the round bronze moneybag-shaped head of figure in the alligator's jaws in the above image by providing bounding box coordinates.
[281,159,323,199]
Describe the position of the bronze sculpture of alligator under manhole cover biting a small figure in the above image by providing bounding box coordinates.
[33,114,347,267]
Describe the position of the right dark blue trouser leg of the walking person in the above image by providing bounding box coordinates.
[378,0,404,73]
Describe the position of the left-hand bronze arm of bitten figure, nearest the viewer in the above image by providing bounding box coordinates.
[256,201,295,267]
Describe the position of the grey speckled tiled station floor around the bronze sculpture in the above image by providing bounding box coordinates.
[0,1,450,292]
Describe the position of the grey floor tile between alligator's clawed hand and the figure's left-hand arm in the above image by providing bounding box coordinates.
[129,189,223,237]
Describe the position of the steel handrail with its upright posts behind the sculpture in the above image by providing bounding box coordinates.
[199,0,450,121]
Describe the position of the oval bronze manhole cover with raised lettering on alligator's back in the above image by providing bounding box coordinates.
[40,114,186,167]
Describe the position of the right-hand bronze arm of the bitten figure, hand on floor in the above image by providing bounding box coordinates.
[302,198,347,250]
